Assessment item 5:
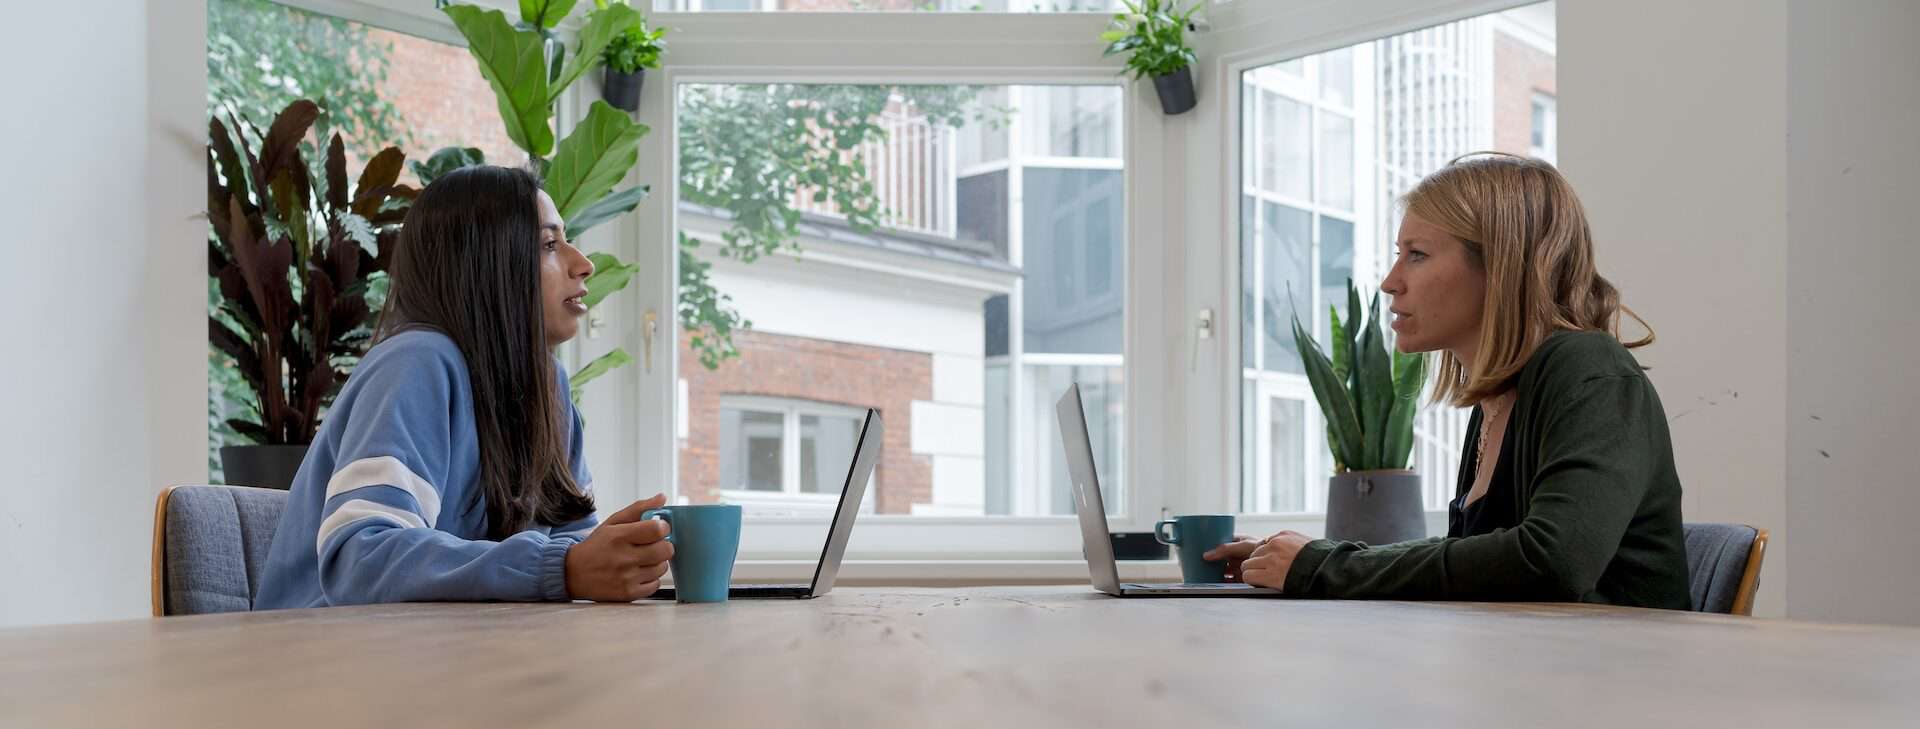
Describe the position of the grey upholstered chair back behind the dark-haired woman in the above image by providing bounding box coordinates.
[154,485,286,618]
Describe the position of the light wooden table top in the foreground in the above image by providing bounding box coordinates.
[0,587,1920,729]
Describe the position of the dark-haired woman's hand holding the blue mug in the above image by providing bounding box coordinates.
[566,495,674,602]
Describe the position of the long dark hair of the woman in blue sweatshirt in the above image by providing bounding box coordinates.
[376,167,593,541]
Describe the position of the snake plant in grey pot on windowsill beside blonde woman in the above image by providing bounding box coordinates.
[1269,280,1427,545]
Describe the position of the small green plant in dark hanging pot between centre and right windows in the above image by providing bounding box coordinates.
[1100,0,1200,115]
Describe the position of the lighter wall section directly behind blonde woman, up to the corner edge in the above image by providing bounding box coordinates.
[1559,0,1791,616]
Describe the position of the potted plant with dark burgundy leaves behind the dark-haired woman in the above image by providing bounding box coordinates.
[207,100,415,489]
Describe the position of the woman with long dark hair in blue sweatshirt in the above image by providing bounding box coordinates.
[255,167,674,608]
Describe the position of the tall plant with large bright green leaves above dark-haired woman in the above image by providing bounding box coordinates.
[435,0,649,399]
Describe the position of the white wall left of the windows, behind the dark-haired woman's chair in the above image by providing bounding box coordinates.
[0,0,207,625]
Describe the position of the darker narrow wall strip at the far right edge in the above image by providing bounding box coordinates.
[1786,0,1920,625]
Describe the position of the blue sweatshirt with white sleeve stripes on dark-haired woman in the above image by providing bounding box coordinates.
[253,330,599,610]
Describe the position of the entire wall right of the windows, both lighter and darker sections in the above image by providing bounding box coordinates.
[1559,0,1920,623]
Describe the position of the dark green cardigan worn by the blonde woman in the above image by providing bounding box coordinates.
[1283,332,1690,610]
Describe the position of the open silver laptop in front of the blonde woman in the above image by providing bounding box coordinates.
[1054,384,1281,597]
